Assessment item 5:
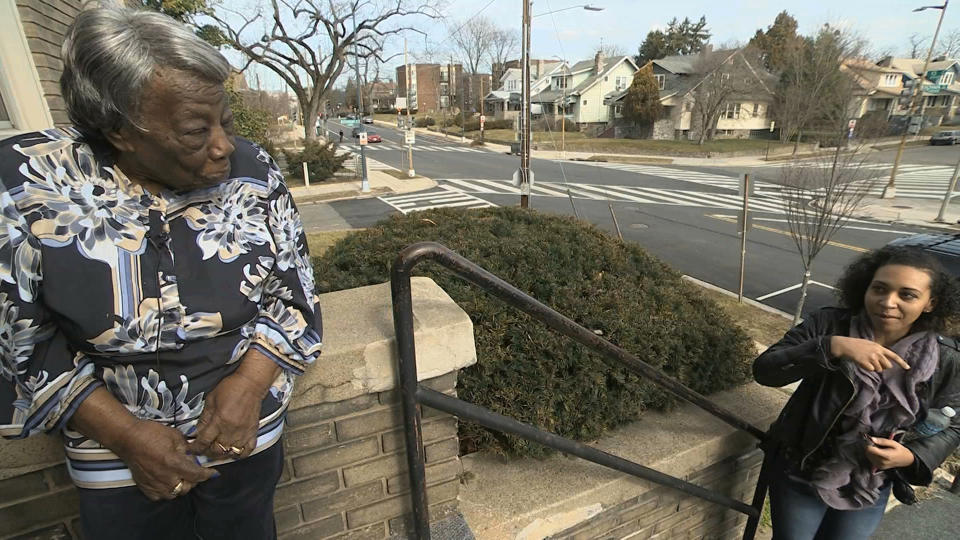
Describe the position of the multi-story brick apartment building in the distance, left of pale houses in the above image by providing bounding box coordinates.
[397,64,463,112]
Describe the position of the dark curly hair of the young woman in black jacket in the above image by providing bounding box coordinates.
[837,246,960,332]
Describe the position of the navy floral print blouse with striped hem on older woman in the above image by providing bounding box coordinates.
[0,129,321,487]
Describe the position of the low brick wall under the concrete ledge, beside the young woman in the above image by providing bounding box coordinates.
[550,450,763,540]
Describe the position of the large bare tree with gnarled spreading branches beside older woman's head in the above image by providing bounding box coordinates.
[209,0,439,139]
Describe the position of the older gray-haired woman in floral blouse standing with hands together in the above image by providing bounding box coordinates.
[0,9,320,540]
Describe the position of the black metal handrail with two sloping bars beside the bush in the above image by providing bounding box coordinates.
[390,242,766,540]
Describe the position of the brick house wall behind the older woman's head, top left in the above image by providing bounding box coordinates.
[17,0,81,125]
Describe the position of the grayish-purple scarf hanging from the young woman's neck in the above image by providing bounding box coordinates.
[810,313,940,510]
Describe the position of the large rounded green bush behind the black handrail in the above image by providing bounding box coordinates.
[314,208,753,456]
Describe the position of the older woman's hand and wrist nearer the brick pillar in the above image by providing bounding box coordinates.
[190,351,280,459]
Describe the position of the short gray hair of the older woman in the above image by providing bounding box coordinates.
[60,8,230,146]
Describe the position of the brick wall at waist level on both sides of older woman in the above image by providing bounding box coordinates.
[0,372,461,540]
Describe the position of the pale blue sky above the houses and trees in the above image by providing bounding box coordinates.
[238,0,960,92]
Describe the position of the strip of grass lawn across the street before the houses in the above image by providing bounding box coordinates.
[467,129,792,155]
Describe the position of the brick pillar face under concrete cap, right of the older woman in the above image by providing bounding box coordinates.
[275,373,460,539]
